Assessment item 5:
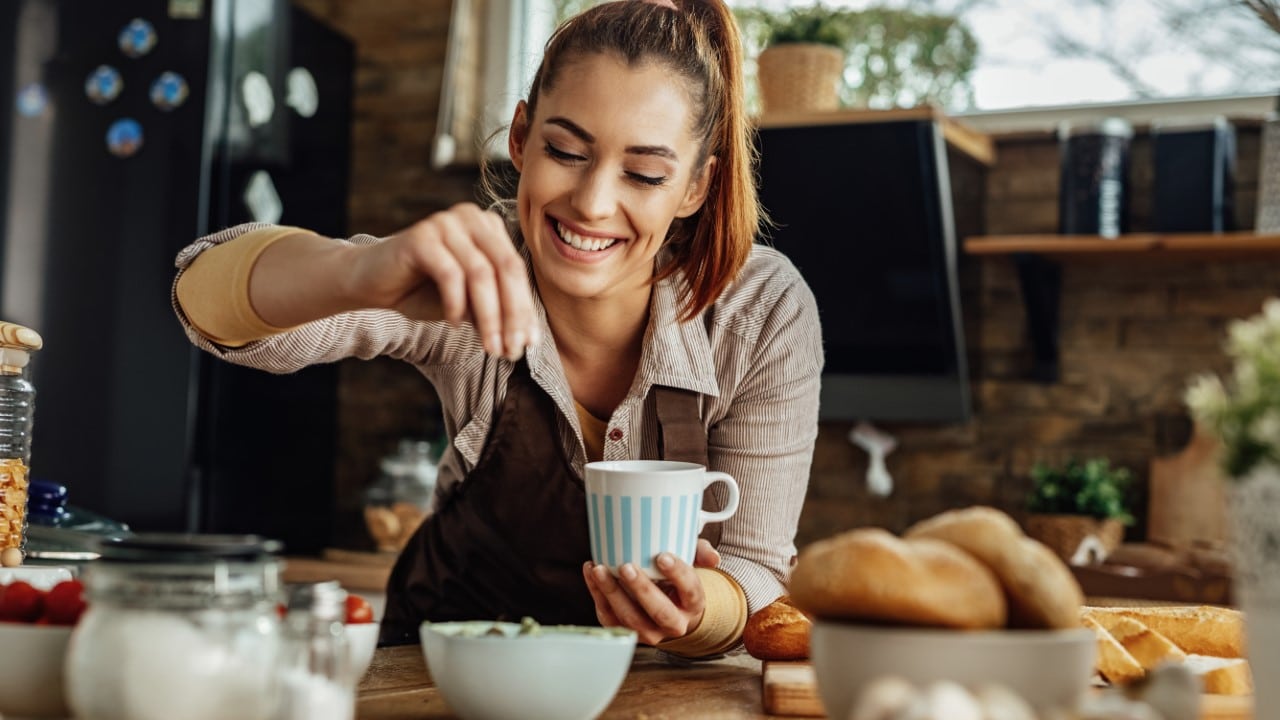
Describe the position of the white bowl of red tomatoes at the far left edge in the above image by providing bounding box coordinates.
[0,623,72,717]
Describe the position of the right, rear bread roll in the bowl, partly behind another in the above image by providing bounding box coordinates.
[904,506,1084,629]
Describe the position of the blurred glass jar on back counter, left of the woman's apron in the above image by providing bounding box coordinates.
[365,439,436,552]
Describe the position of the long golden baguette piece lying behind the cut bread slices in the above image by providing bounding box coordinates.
[1085,605,1245,657]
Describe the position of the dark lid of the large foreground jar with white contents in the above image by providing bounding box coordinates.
[99,533,283,562]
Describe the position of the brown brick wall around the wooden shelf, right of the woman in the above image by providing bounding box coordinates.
[800,124,1280,544]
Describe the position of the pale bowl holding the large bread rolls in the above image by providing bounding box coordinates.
[809,620,1097,717]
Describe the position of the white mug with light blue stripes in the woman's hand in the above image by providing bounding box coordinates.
[586,460,737,579]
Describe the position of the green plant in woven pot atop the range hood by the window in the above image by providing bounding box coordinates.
[736,3,851,113]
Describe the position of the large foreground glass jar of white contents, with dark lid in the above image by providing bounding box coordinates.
[65,534,280,720]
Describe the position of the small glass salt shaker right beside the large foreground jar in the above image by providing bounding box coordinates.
[279,580,356,720]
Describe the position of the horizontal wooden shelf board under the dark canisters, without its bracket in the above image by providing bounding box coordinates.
[964,232,1280,260]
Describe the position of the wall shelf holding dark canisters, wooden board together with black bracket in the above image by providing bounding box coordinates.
[964,231,1280,383]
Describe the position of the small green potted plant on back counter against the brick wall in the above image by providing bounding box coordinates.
[1024,457,1133,564]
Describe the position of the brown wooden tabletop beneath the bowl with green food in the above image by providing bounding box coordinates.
[356,646,776,720]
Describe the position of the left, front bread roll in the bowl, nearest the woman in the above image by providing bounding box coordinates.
[790,520,1007,629]
